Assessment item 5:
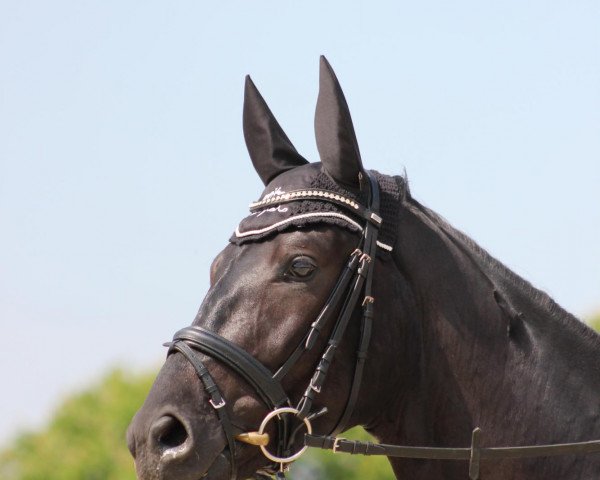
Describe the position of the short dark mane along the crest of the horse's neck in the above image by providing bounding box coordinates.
[399,173,600,343]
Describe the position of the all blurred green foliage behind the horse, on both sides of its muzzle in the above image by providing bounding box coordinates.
[0,312,600,480]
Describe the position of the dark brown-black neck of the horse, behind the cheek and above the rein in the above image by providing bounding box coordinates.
[372,200,600,478]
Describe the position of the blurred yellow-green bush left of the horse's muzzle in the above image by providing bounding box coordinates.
[0,370,154,480]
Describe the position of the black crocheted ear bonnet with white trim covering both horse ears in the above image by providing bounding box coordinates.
[230,57,405,251]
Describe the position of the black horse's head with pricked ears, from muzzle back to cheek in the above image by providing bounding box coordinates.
[128,58,410,480]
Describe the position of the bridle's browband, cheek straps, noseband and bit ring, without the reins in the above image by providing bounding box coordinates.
[166,172,382,480]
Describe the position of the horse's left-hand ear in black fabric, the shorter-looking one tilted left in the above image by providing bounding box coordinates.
[243,75,308,185]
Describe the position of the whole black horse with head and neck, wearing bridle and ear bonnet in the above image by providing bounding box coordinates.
[128,58,600,480]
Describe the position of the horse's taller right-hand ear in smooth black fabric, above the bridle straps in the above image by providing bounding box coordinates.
[315,56,364,188]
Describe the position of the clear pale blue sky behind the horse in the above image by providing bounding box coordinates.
[0,0,600,442]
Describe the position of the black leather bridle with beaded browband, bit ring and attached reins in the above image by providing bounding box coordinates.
[165,172,600,480]
